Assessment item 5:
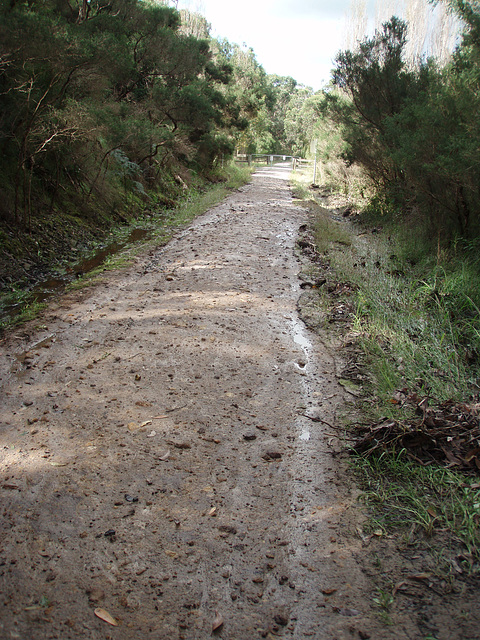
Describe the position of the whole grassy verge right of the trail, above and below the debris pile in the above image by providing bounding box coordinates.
[292,169,480,576]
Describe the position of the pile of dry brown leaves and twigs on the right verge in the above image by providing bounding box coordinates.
[352,392,480,475]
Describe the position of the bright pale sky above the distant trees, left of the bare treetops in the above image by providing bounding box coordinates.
[178,0,360,91]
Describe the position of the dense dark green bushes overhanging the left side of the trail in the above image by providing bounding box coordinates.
[0,0,240,228]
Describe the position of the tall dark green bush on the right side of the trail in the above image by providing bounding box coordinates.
[326,0,480,249]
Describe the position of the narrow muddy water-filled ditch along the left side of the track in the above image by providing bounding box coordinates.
[0,229,151,320]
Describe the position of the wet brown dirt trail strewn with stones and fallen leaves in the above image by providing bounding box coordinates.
[0,168,416,640]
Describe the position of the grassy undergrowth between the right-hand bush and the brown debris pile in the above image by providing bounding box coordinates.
[322,200,480,404]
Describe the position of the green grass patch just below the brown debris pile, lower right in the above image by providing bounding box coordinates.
[354,451,480,573]
